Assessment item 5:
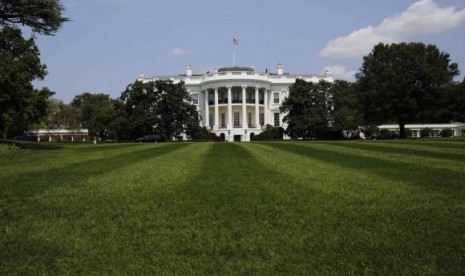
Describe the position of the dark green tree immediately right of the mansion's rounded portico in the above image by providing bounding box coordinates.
[280,79,331,139]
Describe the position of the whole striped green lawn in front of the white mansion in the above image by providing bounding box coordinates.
[0,139,465,275]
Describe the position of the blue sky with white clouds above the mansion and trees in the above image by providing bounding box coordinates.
[34,0,465,102]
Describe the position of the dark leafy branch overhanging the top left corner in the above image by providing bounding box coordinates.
[0,0,69,35]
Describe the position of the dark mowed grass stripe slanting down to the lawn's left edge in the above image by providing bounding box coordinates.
[0,144,189,201]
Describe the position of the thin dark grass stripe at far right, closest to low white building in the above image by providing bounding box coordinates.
[325,141,465,162]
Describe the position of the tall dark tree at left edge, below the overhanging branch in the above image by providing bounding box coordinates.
[0,27,49,138]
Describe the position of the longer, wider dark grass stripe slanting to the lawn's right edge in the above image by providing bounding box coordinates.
[264,143,465,197]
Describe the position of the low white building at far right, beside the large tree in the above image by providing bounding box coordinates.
[378,122,465,138]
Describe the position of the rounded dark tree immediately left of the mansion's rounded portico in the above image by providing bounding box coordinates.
[120,80,199,140]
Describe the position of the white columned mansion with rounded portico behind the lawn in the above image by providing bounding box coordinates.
[137,64,334,142]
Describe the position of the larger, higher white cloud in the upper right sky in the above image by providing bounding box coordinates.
[320,0,465,58]
